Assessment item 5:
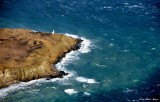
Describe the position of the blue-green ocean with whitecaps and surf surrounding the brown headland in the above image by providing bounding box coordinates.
[0,0,160,102]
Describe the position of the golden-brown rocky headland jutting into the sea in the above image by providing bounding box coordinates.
[0,29,80,88]
